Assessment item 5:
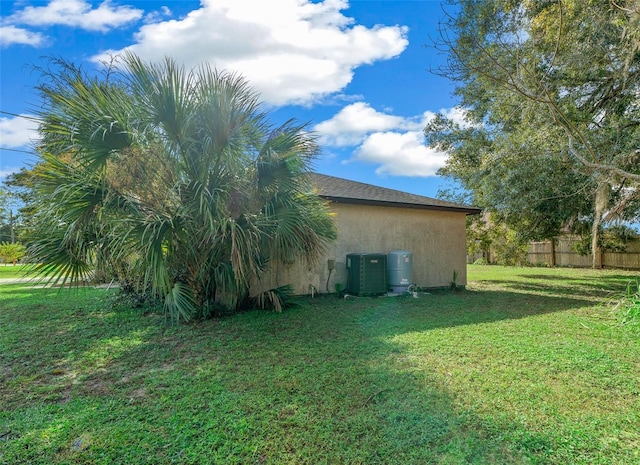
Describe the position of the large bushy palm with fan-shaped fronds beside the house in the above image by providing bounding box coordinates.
[29,50,335,320]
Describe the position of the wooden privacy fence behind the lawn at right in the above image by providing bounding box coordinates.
[527,236,640,270]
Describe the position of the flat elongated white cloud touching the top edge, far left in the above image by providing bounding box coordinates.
[7,0,144,32]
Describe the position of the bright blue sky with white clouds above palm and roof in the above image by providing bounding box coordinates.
[0,0,459,197]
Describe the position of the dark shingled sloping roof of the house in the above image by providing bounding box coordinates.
[311,173,481,215]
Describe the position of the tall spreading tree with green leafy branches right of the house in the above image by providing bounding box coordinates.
[425,0,640,266]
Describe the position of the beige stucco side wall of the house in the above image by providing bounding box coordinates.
[255,203,467,294]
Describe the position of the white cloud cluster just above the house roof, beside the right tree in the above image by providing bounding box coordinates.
[313,102,466,177]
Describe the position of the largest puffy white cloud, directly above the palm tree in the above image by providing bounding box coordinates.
[96,0,408,105]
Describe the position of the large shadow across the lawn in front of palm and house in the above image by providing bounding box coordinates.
[0,280,624,465]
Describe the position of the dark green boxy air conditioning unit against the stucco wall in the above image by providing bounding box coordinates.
[347,253,388,295]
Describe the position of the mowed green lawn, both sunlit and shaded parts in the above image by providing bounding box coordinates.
[0,266,640,465]
